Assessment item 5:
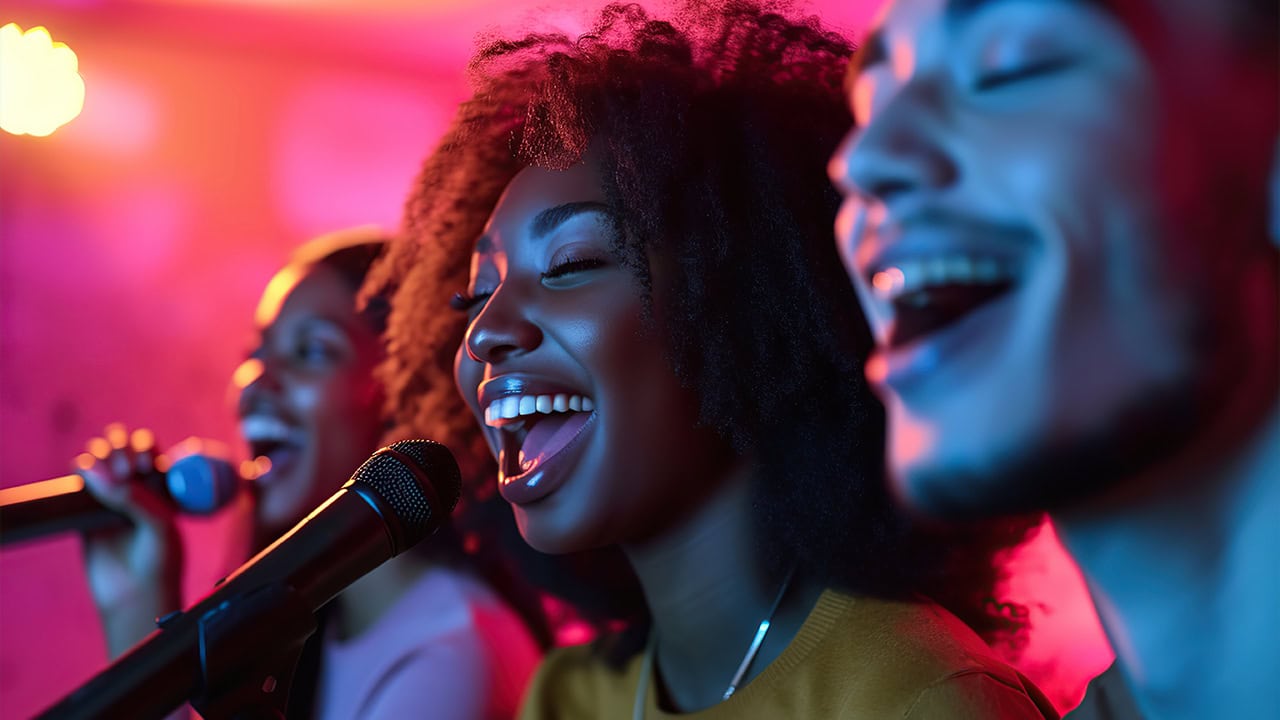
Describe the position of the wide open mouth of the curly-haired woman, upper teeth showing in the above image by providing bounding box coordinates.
[484,393,596,505]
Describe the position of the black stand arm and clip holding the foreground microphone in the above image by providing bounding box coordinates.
[37,582,316,720]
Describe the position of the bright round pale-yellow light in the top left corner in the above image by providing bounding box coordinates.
[0,23,84,137]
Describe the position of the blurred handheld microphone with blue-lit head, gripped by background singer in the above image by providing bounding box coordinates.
[0,455,241,544]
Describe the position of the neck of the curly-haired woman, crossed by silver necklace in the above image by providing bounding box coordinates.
[623,468,822,712]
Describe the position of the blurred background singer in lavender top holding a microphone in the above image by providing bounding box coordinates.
[82,231,539,720]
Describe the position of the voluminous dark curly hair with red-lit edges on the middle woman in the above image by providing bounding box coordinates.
[375,0,1033,648]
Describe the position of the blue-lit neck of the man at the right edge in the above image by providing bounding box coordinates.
[1056,404,1280,719]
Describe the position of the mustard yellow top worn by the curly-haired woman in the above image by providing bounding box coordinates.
[521,589,1059,720]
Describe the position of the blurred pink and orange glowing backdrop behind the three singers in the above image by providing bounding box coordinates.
[0,0,1110,717]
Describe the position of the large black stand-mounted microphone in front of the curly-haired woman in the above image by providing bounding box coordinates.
[40,439,461,719]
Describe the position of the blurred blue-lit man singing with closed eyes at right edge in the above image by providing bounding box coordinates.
[831,0,1280,719]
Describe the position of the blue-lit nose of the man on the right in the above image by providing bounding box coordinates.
[827,82,959,204]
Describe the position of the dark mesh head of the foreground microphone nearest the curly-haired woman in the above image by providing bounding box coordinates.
[351,439,462,550]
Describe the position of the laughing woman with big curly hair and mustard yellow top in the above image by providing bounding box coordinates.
[372,3,1056,719]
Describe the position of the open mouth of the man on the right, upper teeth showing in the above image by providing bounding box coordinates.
[869,254,1018,348]
